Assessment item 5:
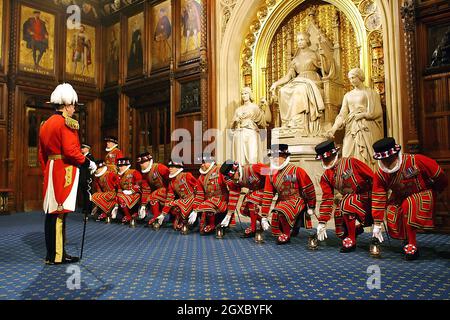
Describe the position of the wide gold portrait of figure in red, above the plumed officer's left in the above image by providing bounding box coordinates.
[19,6,55,75]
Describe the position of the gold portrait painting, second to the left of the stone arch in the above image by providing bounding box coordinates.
[151,0,172,69]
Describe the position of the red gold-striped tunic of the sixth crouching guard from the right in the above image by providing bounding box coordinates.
[163,172,205,219]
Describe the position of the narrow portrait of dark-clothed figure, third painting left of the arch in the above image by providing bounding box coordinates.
[127,12,144,77]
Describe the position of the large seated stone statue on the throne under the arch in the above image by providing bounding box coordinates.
[270,32,334,136]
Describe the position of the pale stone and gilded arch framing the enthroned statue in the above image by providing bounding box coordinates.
[216,0,402,158]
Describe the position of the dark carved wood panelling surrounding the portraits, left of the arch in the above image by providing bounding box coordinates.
[0,0,215,211]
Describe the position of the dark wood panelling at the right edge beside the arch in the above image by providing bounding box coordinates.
[406,0,450,232]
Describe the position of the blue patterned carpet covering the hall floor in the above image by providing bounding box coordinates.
[0,213,450,300]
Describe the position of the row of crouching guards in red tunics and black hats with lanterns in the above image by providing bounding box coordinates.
[92,137,448,260]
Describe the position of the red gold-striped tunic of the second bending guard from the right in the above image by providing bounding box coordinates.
[318,158,373,236]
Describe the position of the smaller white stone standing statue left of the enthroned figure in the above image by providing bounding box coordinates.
[231,87,272,165]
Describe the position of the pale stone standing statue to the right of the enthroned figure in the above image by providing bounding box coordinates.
[327,68,383,169]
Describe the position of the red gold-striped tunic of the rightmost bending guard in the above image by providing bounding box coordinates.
[372,154,448,239]
